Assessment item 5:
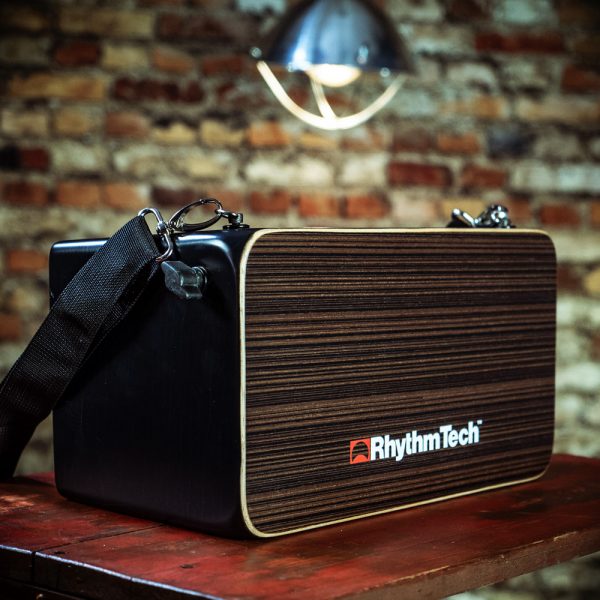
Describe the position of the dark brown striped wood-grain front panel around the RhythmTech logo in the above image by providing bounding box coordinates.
[244,230,556,534]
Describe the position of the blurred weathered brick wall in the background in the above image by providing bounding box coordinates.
[0,0,600,592]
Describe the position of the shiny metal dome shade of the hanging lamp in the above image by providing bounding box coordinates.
[261,0,413,73]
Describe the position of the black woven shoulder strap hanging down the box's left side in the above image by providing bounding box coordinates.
[0,217,160,479]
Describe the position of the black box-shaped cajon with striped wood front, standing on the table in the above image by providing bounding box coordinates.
[50,229,556,537]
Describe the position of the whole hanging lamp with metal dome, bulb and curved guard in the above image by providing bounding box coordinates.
[251,0,414,130]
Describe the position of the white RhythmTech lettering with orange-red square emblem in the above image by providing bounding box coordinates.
[350,419,483,465]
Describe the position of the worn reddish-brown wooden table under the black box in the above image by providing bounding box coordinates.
[0,455,600,600]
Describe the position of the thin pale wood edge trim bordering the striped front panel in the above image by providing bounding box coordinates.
[239,227,554,538]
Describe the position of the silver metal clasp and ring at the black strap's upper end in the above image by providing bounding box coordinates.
[138,198,248,263]
